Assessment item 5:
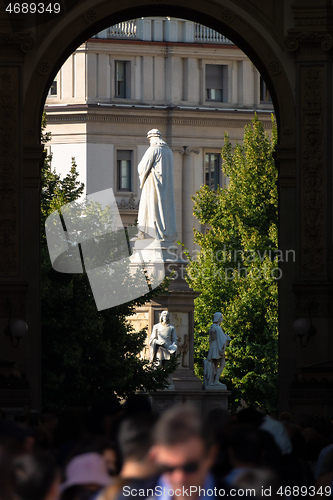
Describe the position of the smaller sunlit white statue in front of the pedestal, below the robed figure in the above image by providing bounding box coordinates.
[149,311,177,365]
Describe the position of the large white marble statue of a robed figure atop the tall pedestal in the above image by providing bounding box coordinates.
[138,129,177,242]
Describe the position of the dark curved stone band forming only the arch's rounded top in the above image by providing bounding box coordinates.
[24,0,295,146]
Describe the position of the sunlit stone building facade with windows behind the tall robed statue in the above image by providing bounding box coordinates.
[45,17,273,251]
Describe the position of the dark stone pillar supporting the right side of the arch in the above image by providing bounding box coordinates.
[285,11,333,414]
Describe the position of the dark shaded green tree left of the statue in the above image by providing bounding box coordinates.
[41,116,176,409]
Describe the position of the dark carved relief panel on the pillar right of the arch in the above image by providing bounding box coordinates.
[299,66,325,276]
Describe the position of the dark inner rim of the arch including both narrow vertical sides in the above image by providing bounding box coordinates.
[19,0,296,409]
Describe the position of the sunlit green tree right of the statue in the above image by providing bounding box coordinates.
[187,116,279,411]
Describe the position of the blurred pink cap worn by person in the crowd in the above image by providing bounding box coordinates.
[60,453,112,492]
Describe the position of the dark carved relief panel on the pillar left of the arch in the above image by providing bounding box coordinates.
[0,67,20,276]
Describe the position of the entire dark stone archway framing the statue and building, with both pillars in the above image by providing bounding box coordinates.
[0,0,332,416]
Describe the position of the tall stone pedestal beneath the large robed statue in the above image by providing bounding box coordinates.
[130,254,230,415]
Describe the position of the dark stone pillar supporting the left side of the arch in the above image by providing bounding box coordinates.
[0,33,42,411]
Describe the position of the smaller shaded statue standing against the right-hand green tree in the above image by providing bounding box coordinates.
[204,312,231,389]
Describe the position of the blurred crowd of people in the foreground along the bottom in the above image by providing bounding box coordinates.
[0,395,333,500]
